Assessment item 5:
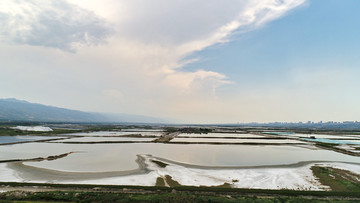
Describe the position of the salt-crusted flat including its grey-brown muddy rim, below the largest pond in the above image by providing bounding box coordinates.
[0,155,360,190]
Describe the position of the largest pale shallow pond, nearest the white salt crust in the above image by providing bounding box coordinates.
[0,143,360,172]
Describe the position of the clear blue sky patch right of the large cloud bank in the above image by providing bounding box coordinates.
[184,0,360,85]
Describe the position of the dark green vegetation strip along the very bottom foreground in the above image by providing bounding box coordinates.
[0,190,358,203]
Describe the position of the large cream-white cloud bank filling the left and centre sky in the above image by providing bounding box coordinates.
[0,0,305,122]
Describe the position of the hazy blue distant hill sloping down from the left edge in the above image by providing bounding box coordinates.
[0,99,166,123]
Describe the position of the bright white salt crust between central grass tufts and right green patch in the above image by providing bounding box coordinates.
[146,155,326,190]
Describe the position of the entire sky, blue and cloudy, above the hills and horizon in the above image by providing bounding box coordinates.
[0,0,360,123]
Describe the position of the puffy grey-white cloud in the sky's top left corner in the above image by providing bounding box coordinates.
[0,0,112,51]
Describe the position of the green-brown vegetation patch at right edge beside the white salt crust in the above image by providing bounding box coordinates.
[311,166,360,193]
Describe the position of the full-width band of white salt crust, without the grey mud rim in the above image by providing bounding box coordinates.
[0,155,360,190]
